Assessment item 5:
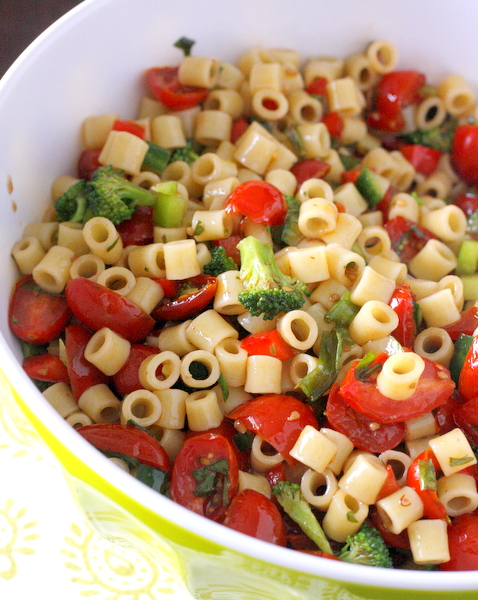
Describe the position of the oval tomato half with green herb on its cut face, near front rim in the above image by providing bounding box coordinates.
[171,433,239,521]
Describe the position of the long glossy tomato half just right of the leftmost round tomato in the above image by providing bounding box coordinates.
[65,277,155,343]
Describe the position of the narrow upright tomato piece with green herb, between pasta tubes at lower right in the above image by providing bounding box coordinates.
[407,448,448,521]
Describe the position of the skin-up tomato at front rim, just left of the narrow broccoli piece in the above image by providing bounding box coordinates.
[223,489,286,546]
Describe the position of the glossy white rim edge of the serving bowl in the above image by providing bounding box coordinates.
[0,0,478,592]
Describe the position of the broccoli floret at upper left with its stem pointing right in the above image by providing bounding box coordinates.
[85,165,159,225]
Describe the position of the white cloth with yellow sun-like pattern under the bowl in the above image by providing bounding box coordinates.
[0,400,191,600]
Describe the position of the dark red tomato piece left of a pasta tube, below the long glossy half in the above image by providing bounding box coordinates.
[65,323,109,399]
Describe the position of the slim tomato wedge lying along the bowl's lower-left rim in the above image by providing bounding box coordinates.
[77,423,170,472]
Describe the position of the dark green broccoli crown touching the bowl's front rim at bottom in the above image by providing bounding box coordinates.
[338,524,393,569]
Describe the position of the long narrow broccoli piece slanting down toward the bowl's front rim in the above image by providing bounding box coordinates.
[273,481,333,554]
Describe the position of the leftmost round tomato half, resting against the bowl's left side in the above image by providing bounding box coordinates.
[8,275,71,345]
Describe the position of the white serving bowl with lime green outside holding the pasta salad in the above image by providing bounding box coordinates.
[0,0,478,600]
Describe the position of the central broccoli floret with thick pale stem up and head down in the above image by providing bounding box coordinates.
[237,236,309,320]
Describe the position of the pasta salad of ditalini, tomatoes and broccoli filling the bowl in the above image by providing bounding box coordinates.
[9,34,478,570]
